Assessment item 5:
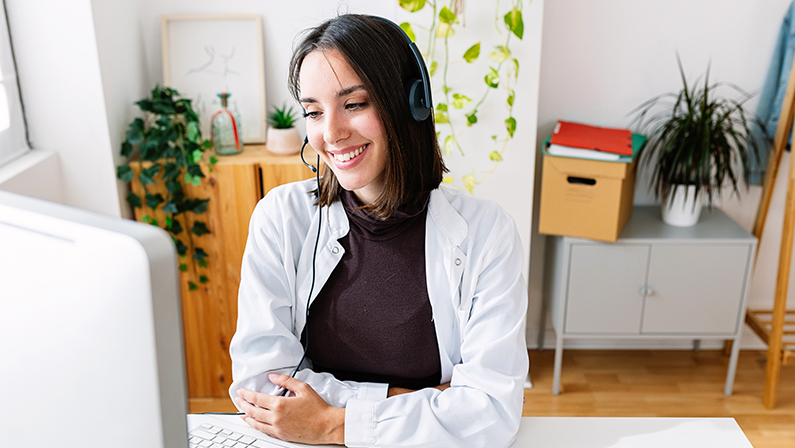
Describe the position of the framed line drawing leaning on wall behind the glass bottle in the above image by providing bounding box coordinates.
[161,15,266,143]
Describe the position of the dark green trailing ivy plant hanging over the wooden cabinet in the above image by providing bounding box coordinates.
[116,86,218,291]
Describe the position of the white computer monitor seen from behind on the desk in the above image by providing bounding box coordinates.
[0,191,188,448]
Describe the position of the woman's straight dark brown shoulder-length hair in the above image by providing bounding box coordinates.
[288,14,447,218]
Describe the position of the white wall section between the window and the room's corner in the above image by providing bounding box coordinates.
[6,0,119,216]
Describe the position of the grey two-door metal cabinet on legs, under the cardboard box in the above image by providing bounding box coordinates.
[538,207,757,395]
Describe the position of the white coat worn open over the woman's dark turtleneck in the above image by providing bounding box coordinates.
[229,180,528,447]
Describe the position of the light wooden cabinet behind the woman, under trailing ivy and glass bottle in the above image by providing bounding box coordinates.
[131,145,313,398]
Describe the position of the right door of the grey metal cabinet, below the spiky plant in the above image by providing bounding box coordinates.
[642,245,751,335]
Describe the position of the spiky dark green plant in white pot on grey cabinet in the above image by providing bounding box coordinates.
[632,57,761,227]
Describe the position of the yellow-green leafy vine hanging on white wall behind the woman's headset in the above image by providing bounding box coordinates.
[398,0,532,193]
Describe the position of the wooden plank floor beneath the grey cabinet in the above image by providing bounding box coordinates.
[190,350,795,448]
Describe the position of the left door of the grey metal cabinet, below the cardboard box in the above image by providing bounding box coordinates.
[565,244,649,334]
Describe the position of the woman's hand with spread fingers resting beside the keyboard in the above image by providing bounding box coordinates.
[236,373,345,445]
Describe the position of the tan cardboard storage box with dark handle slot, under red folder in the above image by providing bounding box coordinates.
[538,151,636,242]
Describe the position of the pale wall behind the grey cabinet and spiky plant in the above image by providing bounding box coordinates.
[531,0,790,347]
